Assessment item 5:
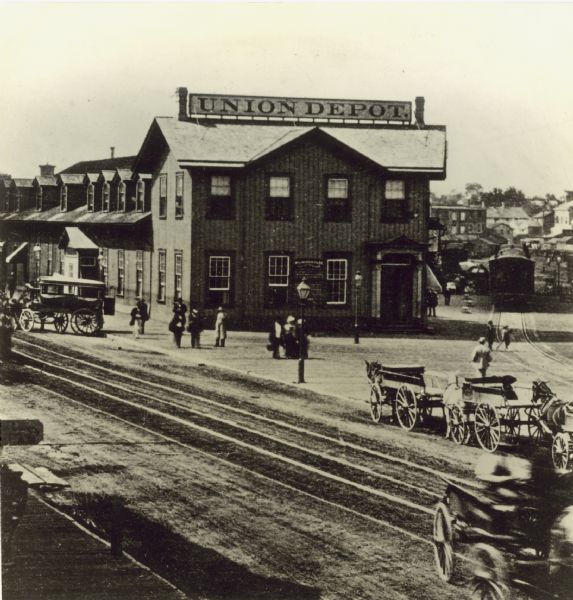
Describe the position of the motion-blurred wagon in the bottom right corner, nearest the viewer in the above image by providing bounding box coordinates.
[432,481,573,600]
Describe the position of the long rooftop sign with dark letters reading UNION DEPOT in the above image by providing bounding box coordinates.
[189,94,412,123]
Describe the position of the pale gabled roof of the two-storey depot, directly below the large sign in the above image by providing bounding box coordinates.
[138,117,446,174]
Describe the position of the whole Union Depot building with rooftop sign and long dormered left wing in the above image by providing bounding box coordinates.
[0,88,446,330]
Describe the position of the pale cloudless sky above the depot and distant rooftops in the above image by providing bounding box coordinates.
[0,2,573,196]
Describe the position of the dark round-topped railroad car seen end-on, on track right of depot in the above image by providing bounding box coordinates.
[489,244,535,307]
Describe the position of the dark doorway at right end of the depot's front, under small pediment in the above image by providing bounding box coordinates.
[380,254,414,325]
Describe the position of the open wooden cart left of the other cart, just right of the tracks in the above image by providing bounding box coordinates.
[366,361,448,431]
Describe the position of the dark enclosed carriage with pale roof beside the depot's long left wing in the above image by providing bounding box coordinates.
[19,274,115,335]
